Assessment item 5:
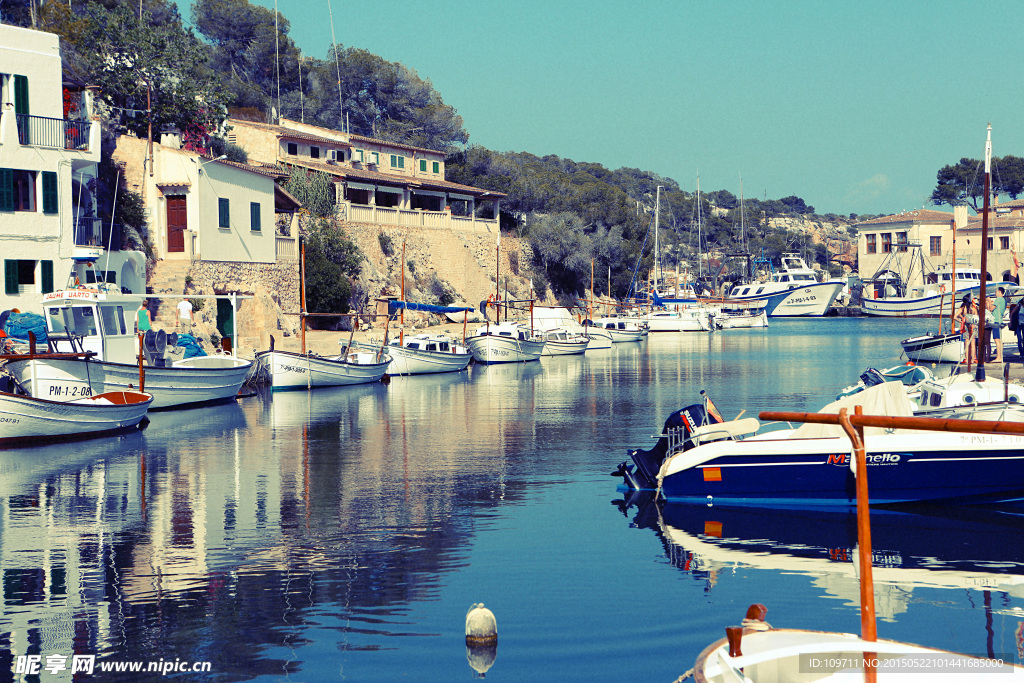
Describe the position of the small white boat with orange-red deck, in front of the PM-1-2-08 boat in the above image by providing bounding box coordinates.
[0,391,153,445]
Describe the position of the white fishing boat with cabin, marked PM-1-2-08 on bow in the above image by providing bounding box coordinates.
[6,283,251,410]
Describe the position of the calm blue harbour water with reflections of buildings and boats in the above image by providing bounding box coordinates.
[0,318,1024,682]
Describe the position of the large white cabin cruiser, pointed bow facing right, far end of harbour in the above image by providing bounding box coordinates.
[727,254,846,317]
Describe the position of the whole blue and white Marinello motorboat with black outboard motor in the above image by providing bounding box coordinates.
[616,382,1024,507]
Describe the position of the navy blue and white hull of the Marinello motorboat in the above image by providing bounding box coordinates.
[662,432,1024,507]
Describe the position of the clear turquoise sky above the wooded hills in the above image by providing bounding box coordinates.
[179,0,1024,214]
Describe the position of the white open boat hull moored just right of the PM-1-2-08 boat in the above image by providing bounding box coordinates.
[256,351,391,391]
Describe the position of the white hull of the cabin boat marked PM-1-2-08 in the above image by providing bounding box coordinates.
[6,355,252,411]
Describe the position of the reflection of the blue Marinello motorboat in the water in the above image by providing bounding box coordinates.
[616,492,1024,621]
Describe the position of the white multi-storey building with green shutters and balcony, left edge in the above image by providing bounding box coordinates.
[0,26,145,312]
